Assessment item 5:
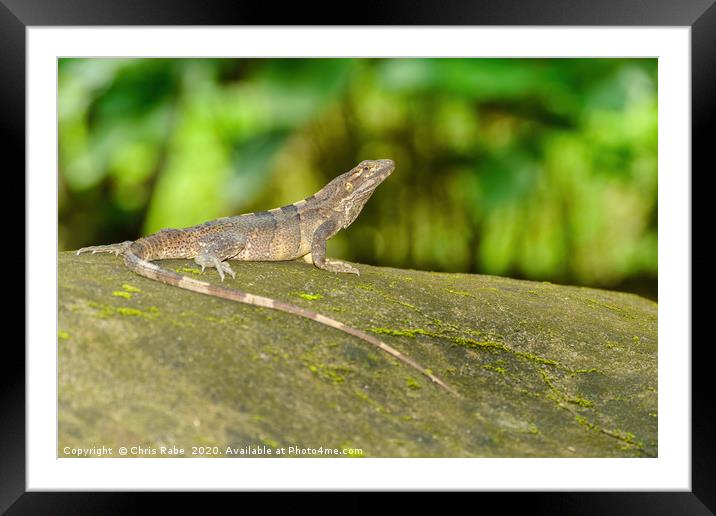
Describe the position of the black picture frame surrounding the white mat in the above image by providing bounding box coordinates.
[0,0,716,514]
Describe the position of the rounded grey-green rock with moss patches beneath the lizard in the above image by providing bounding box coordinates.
[58,252,657,457]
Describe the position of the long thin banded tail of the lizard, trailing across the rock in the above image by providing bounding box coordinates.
[124,248,460,396]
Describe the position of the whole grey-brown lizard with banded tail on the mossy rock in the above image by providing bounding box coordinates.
[77,159,458,395]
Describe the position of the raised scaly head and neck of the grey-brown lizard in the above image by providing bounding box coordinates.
[324,159,395,228]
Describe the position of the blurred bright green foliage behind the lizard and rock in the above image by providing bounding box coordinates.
[58,59,657,297]
